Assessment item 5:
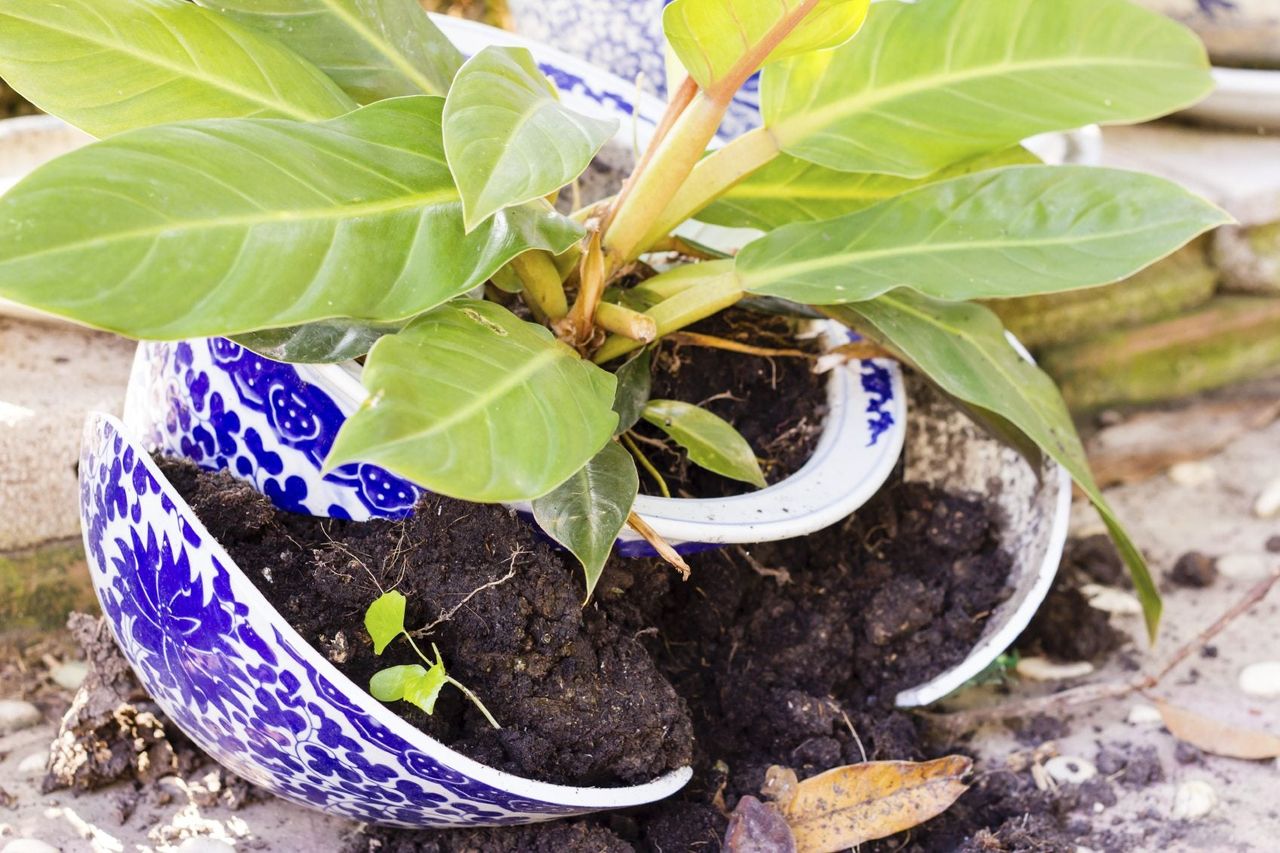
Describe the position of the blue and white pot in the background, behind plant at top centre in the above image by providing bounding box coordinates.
[507,0,760,137]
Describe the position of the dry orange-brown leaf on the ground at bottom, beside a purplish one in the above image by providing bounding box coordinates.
[782,756,973,853]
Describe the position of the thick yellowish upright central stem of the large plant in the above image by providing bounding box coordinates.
[604,92,731,270]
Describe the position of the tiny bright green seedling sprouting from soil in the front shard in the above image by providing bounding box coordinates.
[365,592,502,729]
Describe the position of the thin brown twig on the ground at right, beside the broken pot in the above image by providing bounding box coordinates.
[922,570,1280,734]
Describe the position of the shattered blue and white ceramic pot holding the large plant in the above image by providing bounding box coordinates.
[57,9,1070,827]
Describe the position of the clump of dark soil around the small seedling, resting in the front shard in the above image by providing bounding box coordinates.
[165,462,692,785]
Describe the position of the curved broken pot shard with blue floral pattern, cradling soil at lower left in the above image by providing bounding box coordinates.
[81,412,689,827]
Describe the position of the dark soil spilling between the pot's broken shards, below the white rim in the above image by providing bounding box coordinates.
[157,462,1069,853]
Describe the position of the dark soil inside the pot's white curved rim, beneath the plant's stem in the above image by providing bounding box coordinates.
[636,310,827,498]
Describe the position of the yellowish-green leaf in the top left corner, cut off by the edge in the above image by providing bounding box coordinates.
[0,0,356,137]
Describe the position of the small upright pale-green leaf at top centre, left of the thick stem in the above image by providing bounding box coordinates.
[444,47,618,231]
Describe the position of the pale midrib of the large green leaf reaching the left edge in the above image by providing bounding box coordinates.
[0,187,458,266]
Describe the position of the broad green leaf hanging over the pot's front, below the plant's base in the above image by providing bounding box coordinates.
[328,300,618,503]
